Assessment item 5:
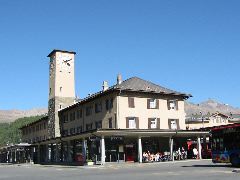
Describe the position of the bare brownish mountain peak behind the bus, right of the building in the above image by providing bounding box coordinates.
[185,99,240,116]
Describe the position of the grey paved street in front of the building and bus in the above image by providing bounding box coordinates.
[0,160,240,180]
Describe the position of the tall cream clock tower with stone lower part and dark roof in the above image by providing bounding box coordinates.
[47,50,76,138]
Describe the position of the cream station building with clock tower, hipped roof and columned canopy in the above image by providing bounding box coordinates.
[1,50,209,165]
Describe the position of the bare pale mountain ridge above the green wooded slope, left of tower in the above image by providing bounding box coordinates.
[0,108,47,123]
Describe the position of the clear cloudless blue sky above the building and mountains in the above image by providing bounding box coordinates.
[0,0,240,109]
